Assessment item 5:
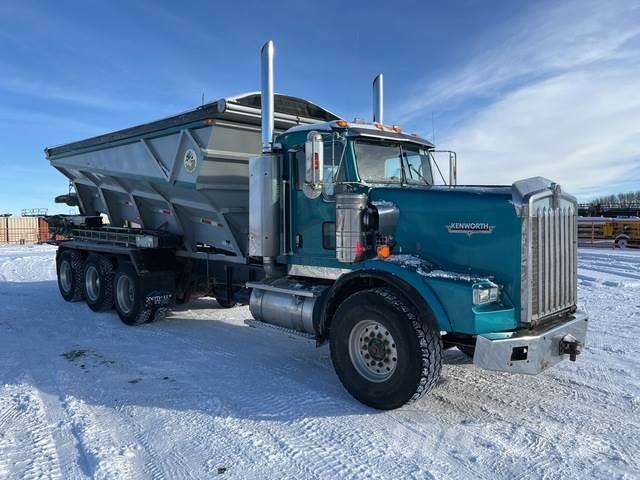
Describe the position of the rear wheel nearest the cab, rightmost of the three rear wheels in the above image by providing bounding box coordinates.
[113,262,153,325]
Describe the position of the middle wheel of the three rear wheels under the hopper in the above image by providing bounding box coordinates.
[82,254,113,312]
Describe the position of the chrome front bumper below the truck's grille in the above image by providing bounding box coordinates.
[473,311,589,375]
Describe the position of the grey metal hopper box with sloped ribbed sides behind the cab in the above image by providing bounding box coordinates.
[45,93,338,263]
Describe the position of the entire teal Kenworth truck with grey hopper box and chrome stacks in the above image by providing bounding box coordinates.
[45,42,588,409]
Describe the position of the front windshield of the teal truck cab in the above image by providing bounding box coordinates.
[355,141,433,185]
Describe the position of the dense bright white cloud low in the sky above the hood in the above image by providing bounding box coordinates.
[446,70,640,191]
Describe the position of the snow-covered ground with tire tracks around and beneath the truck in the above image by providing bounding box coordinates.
[0,246,640,479]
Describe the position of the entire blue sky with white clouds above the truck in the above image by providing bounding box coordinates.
[0,0,640,213]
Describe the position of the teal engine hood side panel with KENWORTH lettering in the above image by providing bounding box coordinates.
[370,182,522,310]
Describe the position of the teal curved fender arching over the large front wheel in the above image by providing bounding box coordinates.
[318,260,451,340]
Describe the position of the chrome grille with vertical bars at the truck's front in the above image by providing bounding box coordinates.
[530,202,578,322]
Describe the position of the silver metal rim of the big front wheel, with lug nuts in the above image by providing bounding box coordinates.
[349,320,398,383]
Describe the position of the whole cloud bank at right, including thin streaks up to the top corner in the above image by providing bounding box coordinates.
[400,2,640,195]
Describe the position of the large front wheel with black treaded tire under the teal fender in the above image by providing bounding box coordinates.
[329,288,442,410]
